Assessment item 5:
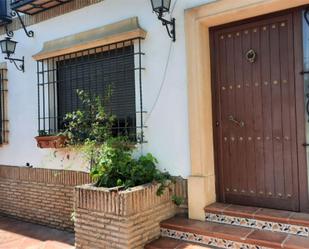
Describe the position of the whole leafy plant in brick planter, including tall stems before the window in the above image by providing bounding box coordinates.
[63,91,183,202]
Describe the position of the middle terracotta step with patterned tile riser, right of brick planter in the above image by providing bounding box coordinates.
[161,217,309,249]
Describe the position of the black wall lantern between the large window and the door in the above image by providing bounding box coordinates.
[151,0,176,42]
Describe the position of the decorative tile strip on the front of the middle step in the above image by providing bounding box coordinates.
[161,228,270,249]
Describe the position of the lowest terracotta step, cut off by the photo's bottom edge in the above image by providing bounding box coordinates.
[145,238,214,249]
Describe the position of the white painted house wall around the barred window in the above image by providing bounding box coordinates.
[0,0,210,177]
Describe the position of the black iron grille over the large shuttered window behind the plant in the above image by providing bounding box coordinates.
[37,38,144,142]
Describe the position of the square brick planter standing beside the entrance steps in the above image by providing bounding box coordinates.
[75,184,180,249]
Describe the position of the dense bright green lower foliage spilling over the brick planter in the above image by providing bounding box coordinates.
[88,137,172,195]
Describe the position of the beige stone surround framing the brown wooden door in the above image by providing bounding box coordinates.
[185,0,309,220]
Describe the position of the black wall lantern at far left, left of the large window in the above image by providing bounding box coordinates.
[0,37,25,72]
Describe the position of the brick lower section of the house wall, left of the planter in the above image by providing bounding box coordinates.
[0,166,90,230]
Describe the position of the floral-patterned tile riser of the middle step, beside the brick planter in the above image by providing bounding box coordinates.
[160,227,272,249]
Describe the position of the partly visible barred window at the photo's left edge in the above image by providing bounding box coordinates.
[0,69,9,144]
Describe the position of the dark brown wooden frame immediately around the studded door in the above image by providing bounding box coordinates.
[209,6,309,212]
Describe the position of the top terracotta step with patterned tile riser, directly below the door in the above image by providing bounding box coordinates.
[205,203,309,237]
